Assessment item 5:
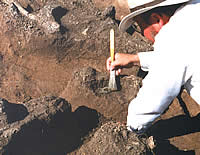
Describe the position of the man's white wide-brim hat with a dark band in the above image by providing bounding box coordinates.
[119,0,190,31]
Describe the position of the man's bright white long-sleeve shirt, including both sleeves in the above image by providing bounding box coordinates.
[127,0,200,131]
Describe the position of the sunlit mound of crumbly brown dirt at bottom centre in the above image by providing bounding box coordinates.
[77,121,150,155]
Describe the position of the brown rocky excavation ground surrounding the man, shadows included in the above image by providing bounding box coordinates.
[0,0,200,155]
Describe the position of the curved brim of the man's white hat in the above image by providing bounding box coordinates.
[119,0,189,32]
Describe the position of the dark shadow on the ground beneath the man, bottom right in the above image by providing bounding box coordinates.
[149,114,200,155]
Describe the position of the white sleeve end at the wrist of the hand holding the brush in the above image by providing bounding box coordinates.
[138,51,156,71]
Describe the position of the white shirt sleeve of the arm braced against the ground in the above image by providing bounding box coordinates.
[127,55,186,131]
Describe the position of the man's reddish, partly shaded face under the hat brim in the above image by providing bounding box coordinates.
[134,13,170,43]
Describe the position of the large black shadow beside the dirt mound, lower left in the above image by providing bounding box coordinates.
[3,106,100,155]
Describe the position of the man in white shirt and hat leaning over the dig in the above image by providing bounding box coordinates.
[107,0,200,133]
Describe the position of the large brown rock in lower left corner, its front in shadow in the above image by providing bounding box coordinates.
[0,96,76,154]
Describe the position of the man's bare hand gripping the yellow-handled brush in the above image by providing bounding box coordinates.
[106,53,140,75]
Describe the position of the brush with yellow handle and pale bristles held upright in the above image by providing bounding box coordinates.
[108,29,117,91]
